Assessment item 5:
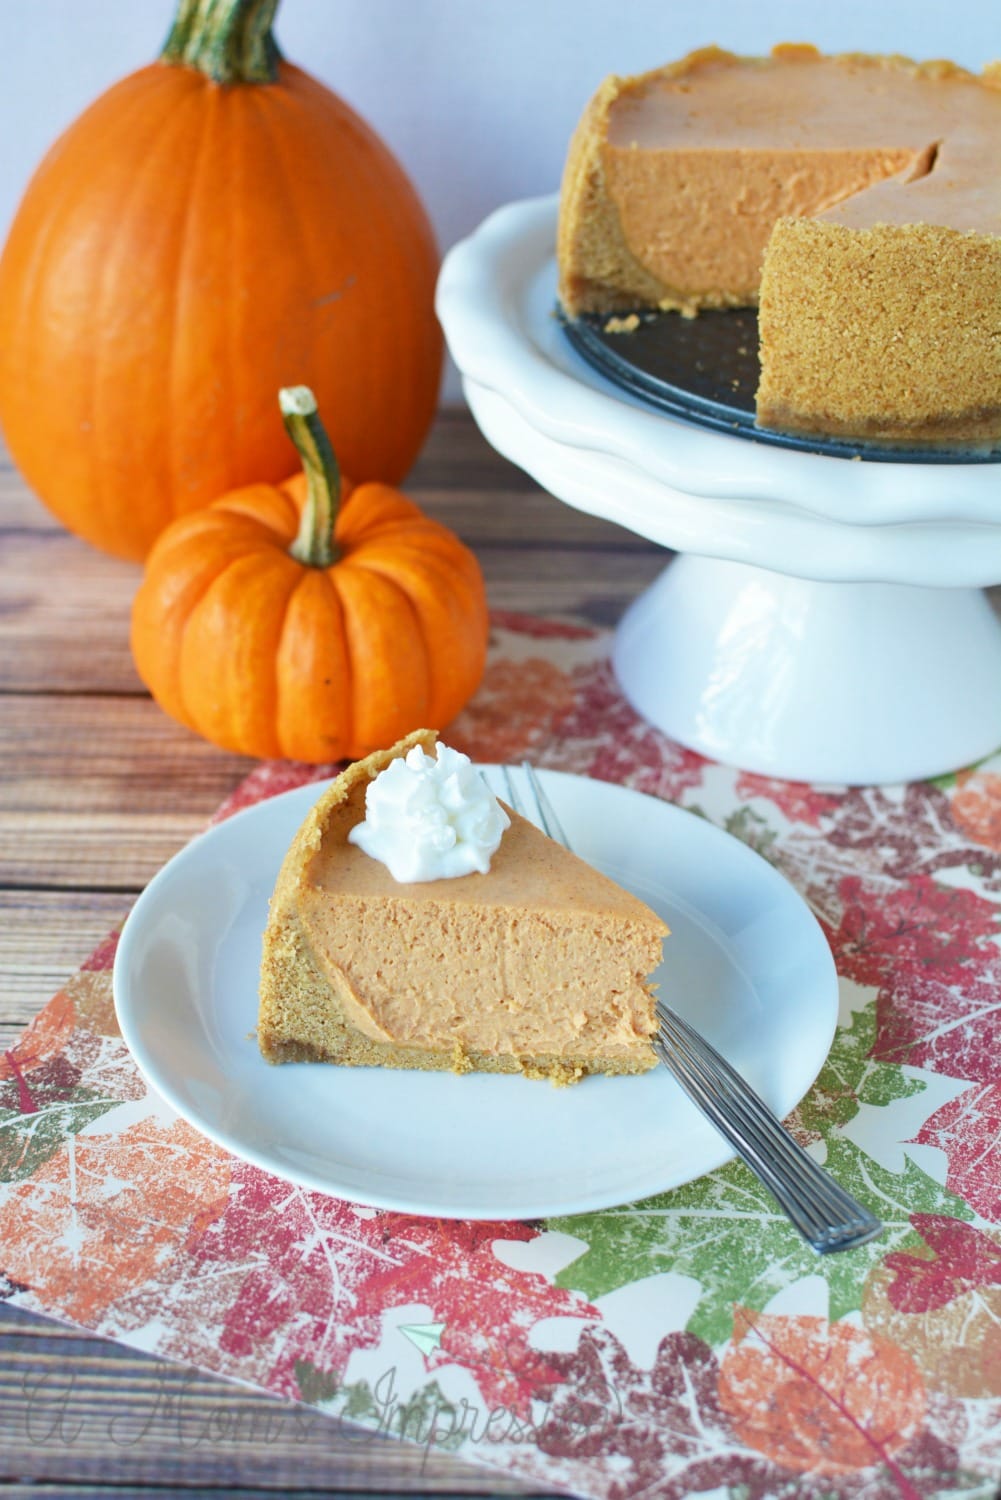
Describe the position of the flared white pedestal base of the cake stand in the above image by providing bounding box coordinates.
[614,554,1001,783]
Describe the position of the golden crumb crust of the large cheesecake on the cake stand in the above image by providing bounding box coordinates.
[557,44,1001,452]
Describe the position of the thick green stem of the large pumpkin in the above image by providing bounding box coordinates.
[161,0,281,84]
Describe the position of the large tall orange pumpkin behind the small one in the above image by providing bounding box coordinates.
[0,0,443,558]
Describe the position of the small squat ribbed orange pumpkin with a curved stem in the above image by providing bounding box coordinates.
[132,386,488,764]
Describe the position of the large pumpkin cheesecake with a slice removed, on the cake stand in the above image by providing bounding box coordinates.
[558,45,1001,444]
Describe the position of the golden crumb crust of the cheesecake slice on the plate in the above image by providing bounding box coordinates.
[257,729,668,1085]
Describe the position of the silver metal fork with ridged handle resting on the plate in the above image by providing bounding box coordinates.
[503,761,882,1256]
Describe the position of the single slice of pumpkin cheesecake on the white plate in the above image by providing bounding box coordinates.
[258,731,668,1083]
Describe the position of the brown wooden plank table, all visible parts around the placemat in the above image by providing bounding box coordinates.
[0,411,665,1500]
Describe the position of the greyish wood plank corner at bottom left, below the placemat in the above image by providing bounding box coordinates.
[0,1310,542,1496]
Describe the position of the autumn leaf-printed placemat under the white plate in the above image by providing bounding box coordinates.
[0,615,1001,1500]
